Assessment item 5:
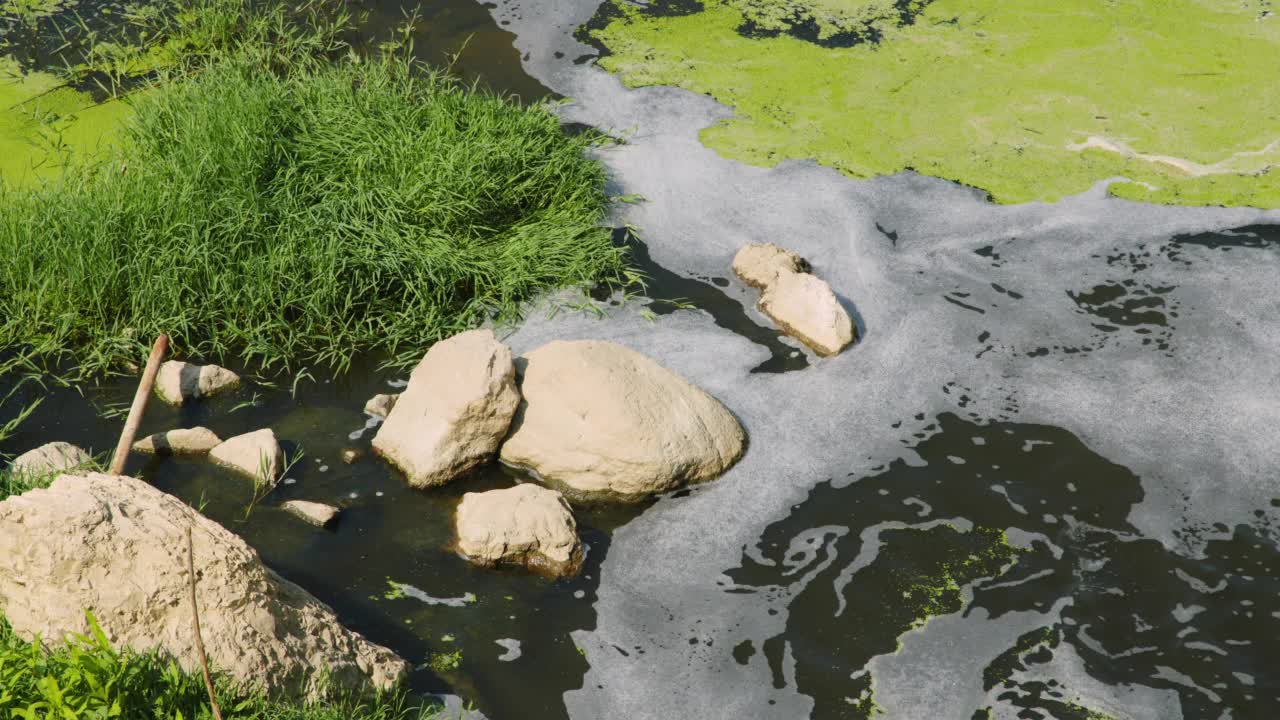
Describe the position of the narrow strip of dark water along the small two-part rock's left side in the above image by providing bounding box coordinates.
[593,228,809,373]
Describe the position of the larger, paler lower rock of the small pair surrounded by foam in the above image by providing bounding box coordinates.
[760,273,854,355]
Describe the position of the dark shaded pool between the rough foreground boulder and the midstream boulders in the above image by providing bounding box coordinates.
[0,353,646,720]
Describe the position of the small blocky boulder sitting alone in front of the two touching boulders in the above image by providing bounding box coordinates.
[454,483,582,578]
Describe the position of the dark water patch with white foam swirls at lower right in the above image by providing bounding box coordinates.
[727,414,1280,719]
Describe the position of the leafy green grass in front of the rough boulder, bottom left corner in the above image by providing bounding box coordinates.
[0,607,440,720]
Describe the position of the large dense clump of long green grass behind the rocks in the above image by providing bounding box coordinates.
[0,53,623,372]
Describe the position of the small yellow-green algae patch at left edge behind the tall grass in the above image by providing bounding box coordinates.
[0,59,131,186]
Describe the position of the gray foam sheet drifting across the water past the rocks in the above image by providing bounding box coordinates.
[481,0,1280,720]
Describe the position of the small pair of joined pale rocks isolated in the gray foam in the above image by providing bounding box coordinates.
[733,243,855,355]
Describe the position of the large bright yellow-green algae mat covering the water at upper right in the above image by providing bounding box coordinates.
[589,0,1280,208]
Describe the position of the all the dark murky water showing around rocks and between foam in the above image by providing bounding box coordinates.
[0,0,1280,720]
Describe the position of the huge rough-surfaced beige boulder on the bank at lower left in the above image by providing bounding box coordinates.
[0,474,408,697]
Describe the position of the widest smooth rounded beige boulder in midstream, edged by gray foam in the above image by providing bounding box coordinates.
[502,341,746,501]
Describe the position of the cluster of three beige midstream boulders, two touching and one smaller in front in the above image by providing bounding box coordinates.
[366,331,746,577]
